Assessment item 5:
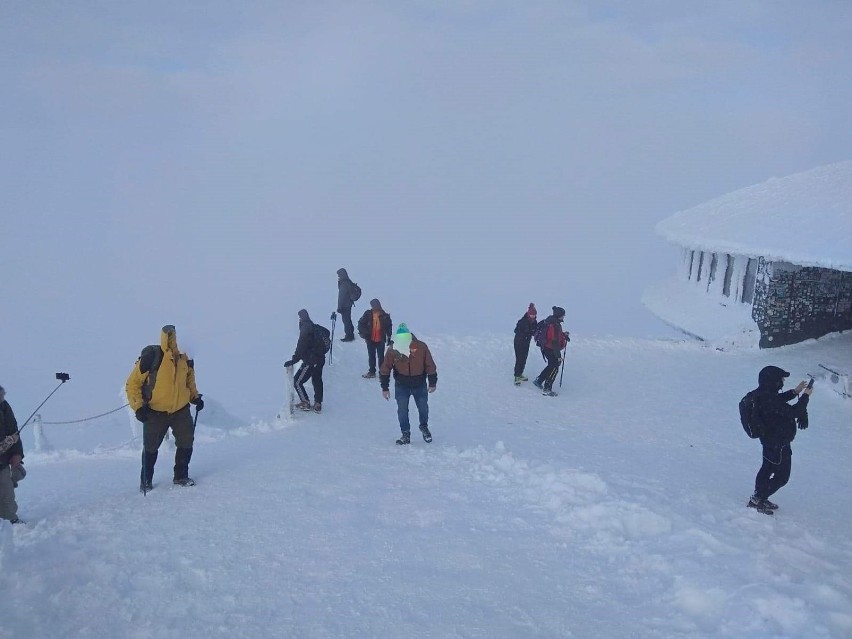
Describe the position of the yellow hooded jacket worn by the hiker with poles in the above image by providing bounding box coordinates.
[126,326,198,414]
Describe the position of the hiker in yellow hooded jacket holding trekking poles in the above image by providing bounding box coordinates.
[125,325,204,491]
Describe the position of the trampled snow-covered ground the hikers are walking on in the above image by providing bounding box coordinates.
[0,335,852,639]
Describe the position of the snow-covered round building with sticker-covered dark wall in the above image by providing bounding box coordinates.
[642,161,852,348]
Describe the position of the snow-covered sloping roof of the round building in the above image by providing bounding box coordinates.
[656,161,852,272]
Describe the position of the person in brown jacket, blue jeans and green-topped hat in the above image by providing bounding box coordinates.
[379,324,438,445]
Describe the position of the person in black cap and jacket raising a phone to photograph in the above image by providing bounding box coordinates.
[747,366,813,515]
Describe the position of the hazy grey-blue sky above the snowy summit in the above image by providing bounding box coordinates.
[0,1,852,416]
